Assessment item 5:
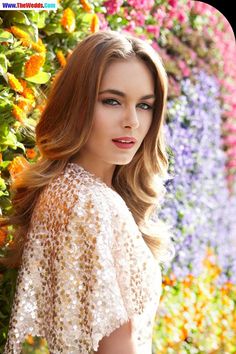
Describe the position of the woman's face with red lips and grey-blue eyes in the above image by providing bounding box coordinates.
[78,59,155,169]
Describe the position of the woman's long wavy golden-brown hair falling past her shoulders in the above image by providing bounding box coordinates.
[0,31,173,267]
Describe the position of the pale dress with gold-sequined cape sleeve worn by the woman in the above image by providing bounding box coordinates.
[4,163,162,354]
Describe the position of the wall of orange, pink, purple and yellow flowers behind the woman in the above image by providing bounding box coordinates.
[0,0,236,354]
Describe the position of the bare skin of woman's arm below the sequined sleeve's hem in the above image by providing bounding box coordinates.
[94,321,137,354]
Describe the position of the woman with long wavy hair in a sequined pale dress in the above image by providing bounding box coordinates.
[0,31,174,354]
